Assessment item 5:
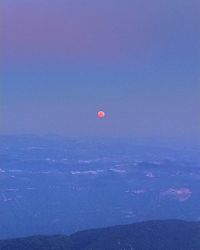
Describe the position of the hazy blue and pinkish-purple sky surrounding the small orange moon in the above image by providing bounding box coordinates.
[0,0,200,140]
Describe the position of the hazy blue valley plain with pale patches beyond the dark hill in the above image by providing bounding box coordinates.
[0,136,200,239]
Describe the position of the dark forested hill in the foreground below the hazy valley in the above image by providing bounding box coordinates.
[0,220,200,250]
